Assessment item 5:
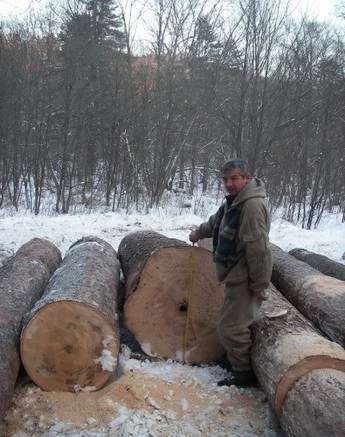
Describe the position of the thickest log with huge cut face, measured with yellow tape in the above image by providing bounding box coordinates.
[118,231,224,364]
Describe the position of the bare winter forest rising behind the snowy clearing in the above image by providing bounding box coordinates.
[0,0,345,229]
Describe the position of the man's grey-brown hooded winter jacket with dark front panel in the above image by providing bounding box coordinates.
[198,178,272,292]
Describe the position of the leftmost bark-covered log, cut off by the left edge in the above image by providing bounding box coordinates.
[0,238,61,419]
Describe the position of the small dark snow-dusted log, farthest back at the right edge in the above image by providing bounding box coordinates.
[289,248,345,281]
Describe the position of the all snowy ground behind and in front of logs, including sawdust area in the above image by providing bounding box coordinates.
[0,202,345,437]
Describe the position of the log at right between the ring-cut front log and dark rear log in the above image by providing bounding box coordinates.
[271,244,345,347]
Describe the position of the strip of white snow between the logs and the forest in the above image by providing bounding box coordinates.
[0,202,345,263]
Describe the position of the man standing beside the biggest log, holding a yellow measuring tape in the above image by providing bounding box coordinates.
[189,159,272,387]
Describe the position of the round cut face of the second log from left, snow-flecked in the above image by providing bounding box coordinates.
[21,300,119,392]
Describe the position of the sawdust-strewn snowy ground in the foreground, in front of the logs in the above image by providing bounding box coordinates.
[0,356,280,437]
